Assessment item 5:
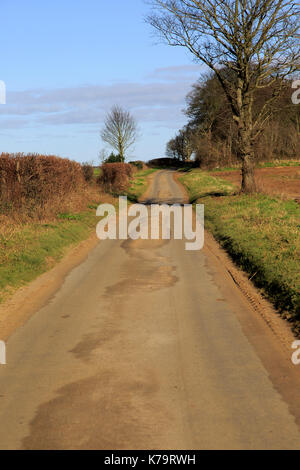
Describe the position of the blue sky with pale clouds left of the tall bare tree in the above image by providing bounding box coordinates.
[0,0,203,162]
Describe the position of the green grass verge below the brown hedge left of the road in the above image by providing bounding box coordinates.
[0,202,104,302]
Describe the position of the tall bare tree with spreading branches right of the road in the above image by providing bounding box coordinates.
[147,0,300,192]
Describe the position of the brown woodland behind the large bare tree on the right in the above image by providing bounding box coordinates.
[166,74,300,168]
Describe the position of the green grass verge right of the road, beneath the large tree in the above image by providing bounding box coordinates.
[179,170,300,336]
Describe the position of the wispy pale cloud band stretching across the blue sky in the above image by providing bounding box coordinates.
[0,65,202,129]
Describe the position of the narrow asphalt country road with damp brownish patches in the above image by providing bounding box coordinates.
[0,172,300,449]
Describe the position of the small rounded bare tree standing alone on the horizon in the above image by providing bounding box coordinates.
[100,106,138,161]
